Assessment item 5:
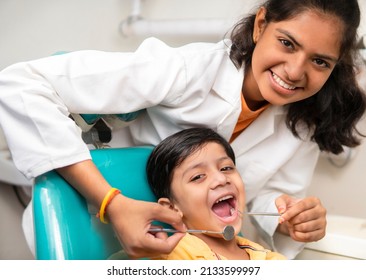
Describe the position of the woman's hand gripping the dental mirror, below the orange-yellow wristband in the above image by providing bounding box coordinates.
[108,195,186,258]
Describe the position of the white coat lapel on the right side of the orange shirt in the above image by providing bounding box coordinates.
[231,106,284,156]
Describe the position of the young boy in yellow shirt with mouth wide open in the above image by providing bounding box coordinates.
[147,128,285,260]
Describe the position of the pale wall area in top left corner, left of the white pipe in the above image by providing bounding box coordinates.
[0,0,129,68]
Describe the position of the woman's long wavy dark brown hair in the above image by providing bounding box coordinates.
[230,0,366,154]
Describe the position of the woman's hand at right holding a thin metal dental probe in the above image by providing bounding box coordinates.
[276,195,327,242]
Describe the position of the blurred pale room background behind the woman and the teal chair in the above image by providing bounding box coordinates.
[0,0,366,259]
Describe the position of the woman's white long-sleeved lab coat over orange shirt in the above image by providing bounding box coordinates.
[0,38,318,258]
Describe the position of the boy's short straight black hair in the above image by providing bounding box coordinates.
[146,128,235,199]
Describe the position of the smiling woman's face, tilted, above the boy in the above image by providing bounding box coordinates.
[243,8,343,107]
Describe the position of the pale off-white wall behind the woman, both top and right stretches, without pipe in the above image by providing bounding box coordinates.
[0,0,366,218]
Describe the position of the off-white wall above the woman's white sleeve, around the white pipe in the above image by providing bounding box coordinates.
[0,0,256,69]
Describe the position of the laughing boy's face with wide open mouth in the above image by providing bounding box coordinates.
[164,142,245,238]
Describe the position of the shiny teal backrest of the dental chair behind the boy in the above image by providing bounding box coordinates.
[33,146,156,260]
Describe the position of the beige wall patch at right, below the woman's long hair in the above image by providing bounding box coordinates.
[309,120,366,219]
